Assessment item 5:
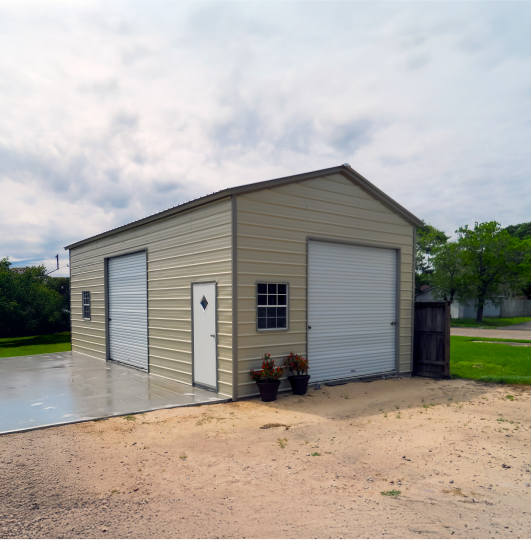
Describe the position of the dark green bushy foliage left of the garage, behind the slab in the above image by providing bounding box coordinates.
[0,258,70,337]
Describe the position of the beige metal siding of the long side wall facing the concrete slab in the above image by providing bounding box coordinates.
[71,198,232,396]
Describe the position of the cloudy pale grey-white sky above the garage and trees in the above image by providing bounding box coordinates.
[0,0,531,275]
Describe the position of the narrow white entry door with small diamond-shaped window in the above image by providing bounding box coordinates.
[192,283,218,391]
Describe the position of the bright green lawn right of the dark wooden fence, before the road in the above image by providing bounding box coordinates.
[450,336,531,384]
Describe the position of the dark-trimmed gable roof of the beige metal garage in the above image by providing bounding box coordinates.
[65,163,424,249]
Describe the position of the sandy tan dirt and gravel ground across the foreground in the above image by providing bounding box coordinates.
[0,378,531,538]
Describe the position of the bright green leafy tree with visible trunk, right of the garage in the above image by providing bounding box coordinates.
[434,221,531,322]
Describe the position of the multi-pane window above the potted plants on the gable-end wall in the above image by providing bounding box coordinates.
[256,283,289,330]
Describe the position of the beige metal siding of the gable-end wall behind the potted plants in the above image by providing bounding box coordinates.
[237,174,413,397]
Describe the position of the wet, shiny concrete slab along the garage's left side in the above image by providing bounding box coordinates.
[0,352,230,434]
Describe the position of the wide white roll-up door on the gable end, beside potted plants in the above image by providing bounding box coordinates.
[308,241,397,381]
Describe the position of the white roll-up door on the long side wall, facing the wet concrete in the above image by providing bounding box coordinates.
[107,251,148,369]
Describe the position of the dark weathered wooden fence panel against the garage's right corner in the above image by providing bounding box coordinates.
[413,302,450,379]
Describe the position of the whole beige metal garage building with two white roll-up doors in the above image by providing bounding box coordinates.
[65,165,422,399]
